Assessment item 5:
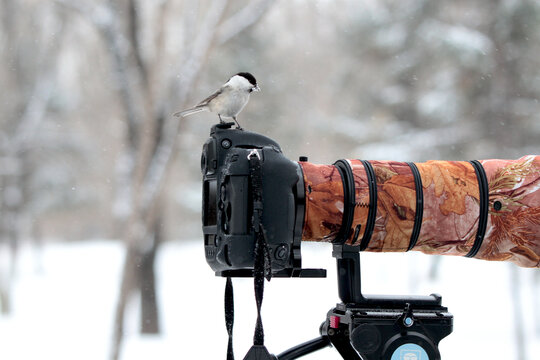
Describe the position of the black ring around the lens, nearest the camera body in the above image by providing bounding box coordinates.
[332,160,356,244]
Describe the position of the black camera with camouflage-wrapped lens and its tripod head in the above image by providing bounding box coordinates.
[201,123,540,360]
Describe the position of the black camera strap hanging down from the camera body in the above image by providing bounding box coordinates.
[225,149,274,360]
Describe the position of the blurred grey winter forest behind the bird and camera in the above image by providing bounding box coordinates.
[0,0,540,359]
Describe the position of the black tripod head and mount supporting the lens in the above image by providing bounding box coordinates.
[274,245,453,360]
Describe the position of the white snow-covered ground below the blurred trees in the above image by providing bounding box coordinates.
[0,240,540,360]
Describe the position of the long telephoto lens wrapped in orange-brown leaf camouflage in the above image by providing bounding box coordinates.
[299,155,540,267]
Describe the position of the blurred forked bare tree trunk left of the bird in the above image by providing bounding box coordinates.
[57,0,272,360]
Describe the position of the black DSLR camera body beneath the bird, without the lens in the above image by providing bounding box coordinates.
[201,123,308,277]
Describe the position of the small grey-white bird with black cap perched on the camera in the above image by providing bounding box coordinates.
[174,72,261,129]
